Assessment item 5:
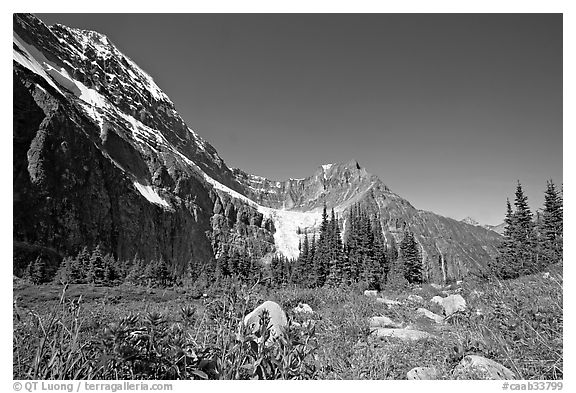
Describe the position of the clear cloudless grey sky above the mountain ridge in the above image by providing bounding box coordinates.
[36,14,563,224]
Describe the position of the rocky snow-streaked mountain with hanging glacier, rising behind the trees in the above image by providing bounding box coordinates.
[13,14,499,282]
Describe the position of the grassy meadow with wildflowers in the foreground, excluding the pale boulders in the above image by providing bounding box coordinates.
[13,267,563,379]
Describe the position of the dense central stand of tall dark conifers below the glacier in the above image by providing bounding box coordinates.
[270,204,423,290]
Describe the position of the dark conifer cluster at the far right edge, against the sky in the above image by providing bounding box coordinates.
[489,180,563,279]
